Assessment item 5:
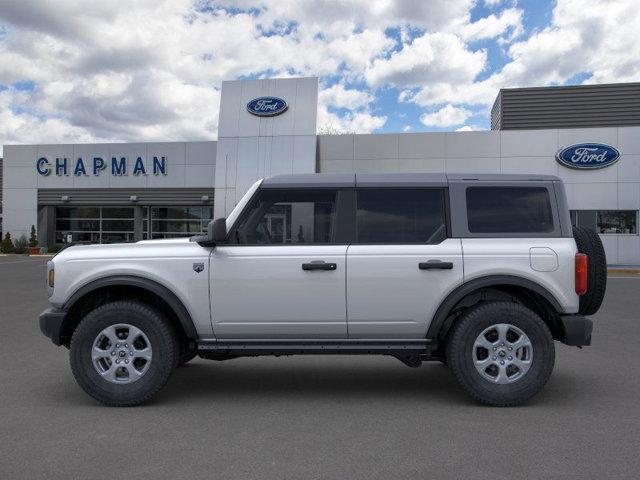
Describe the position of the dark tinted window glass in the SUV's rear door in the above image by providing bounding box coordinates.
[357,188,447,243]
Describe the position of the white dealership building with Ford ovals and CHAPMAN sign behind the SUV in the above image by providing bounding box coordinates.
[0,78,640,264]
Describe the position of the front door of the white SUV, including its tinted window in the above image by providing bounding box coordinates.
[211,188,347,339]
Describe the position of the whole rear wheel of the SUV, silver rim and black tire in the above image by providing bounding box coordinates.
[446,302,555,407]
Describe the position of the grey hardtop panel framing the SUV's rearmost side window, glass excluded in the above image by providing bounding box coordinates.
[449,180,567,238]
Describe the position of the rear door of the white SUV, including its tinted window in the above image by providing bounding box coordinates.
[347,187,463,338]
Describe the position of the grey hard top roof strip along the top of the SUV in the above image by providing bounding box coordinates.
[261,173,560,188]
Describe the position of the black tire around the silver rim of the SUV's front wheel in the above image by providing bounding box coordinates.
[69,301,179,407]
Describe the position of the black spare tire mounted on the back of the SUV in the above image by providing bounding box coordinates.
[573,227,607,315]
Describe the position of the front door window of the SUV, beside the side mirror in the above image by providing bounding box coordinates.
[231,189,337,245]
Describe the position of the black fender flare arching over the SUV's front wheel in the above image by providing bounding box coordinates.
[63,275,198,340]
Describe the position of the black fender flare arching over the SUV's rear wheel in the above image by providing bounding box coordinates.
[427,275,564,341]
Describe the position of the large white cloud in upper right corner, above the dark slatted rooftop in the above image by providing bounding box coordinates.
[403,0,640,112]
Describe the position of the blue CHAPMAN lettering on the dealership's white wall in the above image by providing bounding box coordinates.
[36,156,167,177]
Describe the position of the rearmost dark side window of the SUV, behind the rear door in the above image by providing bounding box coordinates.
[467,187,554,233]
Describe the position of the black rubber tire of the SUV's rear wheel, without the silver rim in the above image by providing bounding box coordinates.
[446,302,555,407]
